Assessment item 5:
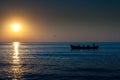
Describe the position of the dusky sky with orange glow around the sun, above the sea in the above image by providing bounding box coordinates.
[0,0,120,42]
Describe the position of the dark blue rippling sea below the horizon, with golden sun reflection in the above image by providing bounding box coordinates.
[0,42,120,80]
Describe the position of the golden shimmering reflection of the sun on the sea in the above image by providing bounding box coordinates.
[11,42,23,80]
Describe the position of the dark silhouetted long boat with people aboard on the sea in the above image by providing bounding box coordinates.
[70,44,99,50]
